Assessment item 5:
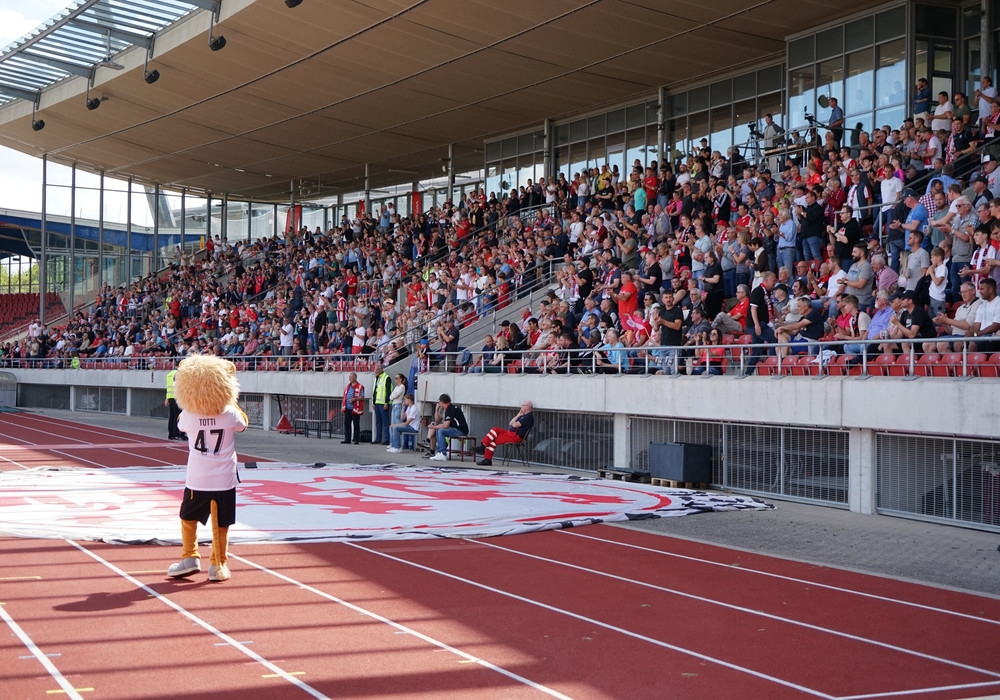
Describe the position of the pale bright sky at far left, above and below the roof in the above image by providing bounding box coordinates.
[0,0,110,212]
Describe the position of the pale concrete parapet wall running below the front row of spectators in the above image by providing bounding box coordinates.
[9,369,1000,439]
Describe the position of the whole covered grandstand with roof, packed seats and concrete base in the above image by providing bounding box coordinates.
[0,0,1000,530]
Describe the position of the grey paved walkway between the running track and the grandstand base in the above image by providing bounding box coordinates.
[27,410,1000,597]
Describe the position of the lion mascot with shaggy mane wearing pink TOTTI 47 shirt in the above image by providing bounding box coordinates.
[167,355,247,581]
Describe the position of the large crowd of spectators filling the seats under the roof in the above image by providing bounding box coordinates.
[2,73,1000,373]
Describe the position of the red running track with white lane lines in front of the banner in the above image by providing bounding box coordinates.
[0,412,1000,699]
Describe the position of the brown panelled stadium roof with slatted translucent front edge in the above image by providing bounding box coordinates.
[0,0,871,201]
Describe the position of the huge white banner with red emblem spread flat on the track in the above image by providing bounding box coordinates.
[0,463,773,544]
